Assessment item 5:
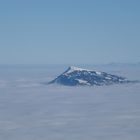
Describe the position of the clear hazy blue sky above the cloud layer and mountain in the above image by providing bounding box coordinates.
[0,0,140,64]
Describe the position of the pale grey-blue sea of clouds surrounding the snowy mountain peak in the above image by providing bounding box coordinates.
[0,66,140,140]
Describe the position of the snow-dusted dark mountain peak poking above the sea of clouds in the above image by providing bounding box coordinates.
[49,66,135,86]
